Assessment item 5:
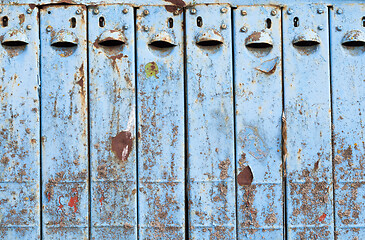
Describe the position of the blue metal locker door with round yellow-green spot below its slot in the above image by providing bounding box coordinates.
[137,6,185,239]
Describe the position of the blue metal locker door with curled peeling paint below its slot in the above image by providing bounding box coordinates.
[233,6,283,239]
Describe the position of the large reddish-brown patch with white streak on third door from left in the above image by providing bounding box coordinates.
[112,131,133,162]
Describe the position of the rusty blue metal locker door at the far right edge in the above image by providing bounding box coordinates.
[330,4,365,239]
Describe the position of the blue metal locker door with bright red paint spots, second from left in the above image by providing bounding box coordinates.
[40,5,89,239]
